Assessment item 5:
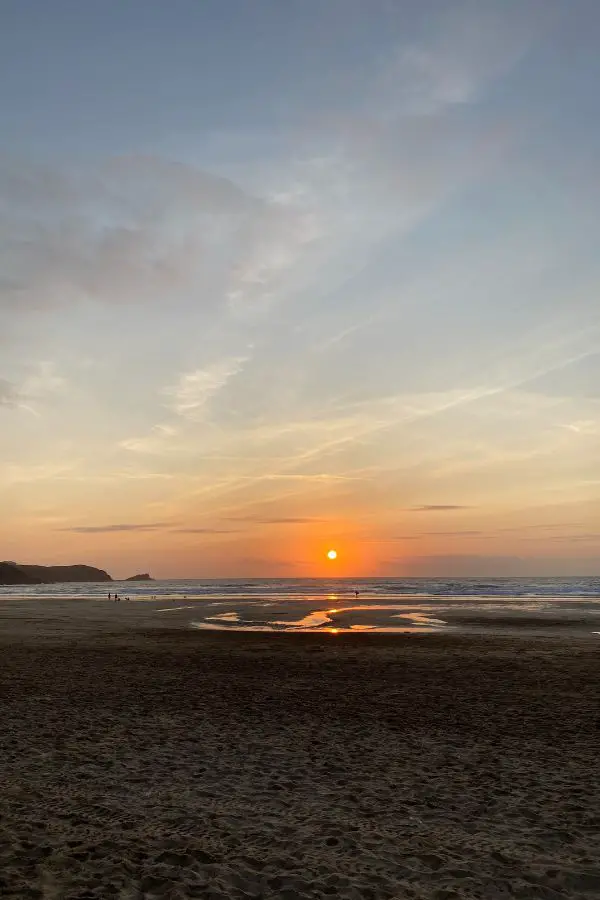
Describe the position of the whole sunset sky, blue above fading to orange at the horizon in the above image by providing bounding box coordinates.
[0,0,600,577]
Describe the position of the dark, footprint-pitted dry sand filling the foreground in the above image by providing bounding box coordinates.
[0,605,600,900]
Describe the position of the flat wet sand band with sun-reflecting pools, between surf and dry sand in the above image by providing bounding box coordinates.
[0,596,600,642]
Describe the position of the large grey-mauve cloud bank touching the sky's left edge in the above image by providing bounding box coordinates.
[0,156,255,315]
